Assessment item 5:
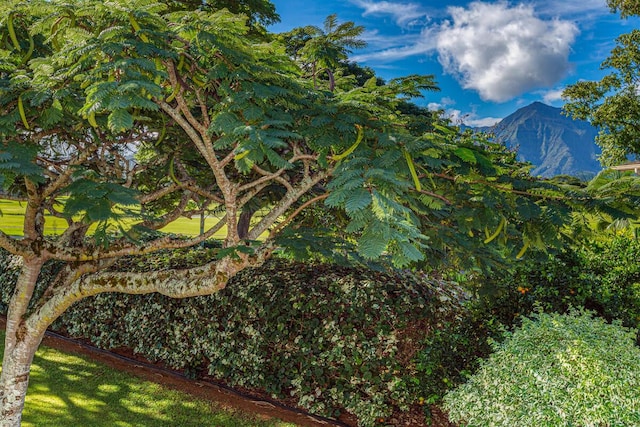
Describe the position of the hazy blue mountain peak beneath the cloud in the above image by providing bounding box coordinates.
[482,102,602,178]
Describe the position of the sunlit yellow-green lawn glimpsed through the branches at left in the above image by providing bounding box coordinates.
[0,199,226,238]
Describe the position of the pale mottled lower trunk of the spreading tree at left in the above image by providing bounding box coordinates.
[0,259,44,427]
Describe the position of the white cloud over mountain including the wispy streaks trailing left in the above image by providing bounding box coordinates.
[350,0,580,102]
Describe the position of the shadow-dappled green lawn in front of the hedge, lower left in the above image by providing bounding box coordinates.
[0,332,295,427]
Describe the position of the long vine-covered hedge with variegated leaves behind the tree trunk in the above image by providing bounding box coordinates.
[0,251,461,426]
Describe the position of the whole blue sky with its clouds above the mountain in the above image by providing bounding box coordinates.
[270,0,640,126]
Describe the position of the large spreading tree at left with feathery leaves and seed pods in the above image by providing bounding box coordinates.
[0,0,462,426]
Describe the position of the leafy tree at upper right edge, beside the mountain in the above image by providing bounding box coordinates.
[563,0,640,166]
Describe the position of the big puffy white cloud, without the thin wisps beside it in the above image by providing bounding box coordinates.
[432,2,578,102]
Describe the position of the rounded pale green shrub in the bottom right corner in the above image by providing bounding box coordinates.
[444,312,640,427]
